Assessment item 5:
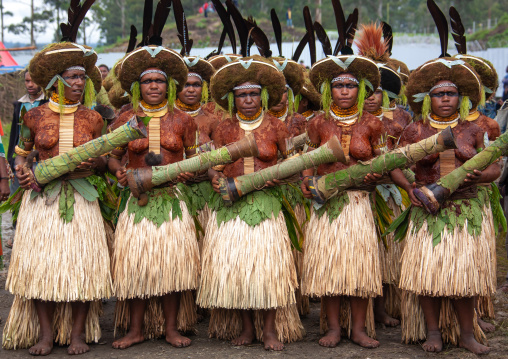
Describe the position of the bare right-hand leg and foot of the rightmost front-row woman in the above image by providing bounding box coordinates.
[453,297,490,354]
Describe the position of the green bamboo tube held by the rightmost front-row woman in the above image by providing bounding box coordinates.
[414,132,508,214]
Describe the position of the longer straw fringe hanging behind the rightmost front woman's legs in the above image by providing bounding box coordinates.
[401,291,487,345]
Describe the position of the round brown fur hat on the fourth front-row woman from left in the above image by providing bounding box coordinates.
[310,55,381,98]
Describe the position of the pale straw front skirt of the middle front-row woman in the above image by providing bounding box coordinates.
[197,212,298,309]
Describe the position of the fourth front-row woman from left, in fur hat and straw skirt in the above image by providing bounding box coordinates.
[302,55,384,348]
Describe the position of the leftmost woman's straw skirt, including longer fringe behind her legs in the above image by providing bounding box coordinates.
[2,191,111,349]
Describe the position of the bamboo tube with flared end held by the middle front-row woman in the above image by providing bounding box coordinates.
[219,136,346,206]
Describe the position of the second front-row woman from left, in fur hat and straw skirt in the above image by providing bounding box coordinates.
[109,45,200,348]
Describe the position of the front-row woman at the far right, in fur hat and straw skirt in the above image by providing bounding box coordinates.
[397,57,500,354]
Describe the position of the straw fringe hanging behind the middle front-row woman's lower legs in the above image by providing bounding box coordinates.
[208,304,305,343]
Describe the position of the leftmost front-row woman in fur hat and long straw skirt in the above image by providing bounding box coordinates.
[3,40,111,355]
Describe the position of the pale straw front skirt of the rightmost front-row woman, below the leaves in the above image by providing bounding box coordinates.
[399,216,496,297]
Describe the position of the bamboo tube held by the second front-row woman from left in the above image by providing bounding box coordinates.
[127,135,259,206]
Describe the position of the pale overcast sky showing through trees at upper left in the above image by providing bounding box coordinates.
[2,0,99,44]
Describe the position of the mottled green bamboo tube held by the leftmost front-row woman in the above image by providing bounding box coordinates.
[33,116,147,184]
